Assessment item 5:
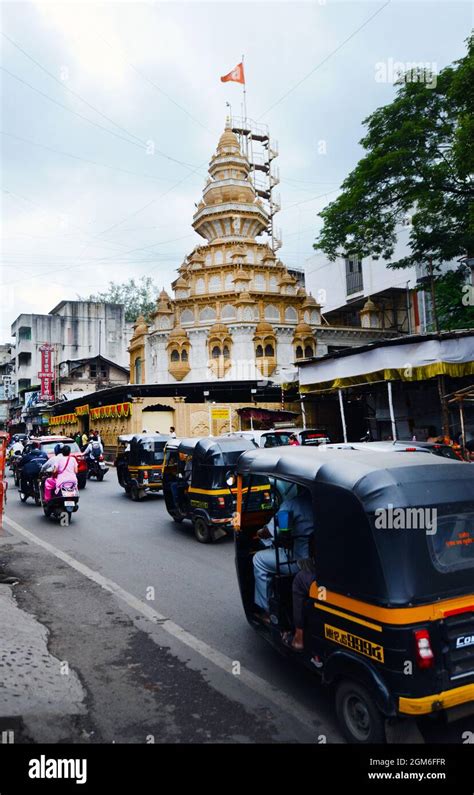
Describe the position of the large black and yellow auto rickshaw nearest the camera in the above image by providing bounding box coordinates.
[235,447,474,743]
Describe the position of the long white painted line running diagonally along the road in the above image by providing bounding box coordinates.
[4,516,338,742]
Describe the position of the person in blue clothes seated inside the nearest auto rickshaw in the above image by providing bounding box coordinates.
[253,485,314,624]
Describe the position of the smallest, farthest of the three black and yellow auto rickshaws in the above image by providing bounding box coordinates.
[115,433,169,500]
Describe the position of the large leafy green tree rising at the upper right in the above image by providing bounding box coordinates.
[315,36,474,326]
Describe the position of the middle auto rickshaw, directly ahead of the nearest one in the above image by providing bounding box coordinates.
[163,437,271,544]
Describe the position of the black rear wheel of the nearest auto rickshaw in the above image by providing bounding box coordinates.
[336,679,386,744]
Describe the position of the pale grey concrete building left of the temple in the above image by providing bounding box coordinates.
[12,301,131,392]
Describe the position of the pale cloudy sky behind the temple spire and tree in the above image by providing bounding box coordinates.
[0,0,473,342]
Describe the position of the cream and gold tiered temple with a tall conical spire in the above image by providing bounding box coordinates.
[130,121,401,385]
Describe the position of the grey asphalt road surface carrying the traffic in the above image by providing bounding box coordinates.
[0,468,472,743]
